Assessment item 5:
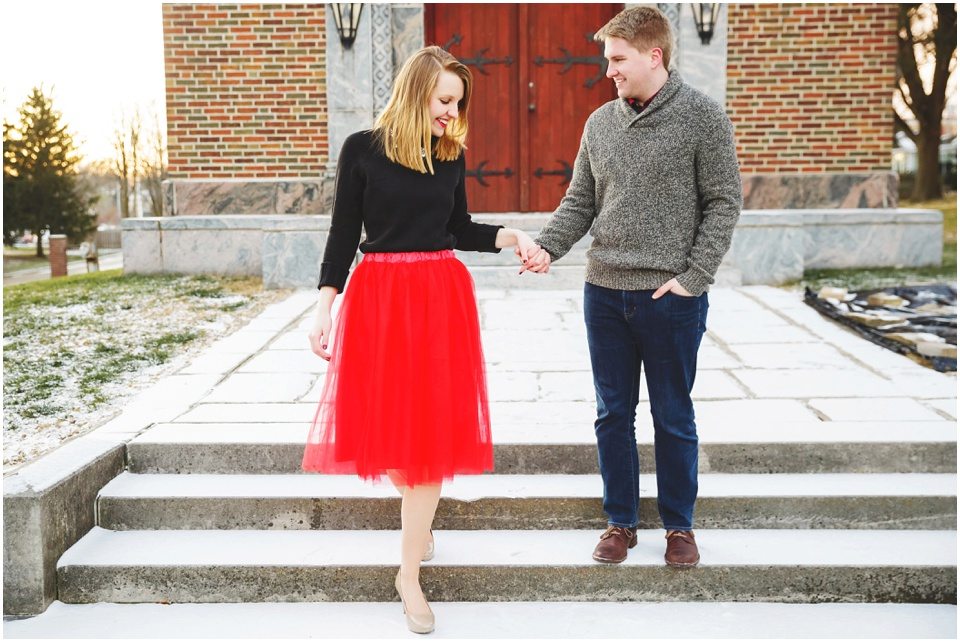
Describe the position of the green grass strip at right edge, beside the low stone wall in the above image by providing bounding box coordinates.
[801,192,957,291]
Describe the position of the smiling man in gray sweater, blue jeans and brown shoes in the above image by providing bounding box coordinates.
[527,7,743,567]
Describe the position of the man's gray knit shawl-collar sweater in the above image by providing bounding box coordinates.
[536,71,743,295]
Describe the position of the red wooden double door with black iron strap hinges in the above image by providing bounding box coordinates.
[425,4,623,212]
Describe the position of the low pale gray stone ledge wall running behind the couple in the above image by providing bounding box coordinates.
[121,209,943,288]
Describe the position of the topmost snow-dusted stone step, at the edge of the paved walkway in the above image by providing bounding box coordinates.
[127,418,957,475]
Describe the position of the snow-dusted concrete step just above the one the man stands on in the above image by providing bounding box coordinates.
[97,472,957,530]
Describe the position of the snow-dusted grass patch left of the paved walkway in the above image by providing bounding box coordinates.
[3,270,288,465]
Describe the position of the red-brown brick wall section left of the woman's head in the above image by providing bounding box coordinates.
[163,4,328,179]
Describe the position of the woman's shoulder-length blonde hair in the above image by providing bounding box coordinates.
[373,46,473,174]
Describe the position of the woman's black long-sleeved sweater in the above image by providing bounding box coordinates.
[317,130,503,292]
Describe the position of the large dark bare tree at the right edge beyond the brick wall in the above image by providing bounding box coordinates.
[894,3,957,201]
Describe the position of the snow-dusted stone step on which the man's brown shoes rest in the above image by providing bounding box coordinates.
[57,526,957,604]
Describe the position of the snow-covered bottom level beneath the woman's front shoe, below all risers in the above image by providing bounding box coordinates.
[3,600,957,640]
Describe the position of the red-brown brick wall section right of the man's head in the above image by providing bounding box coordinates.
[727,4,897,173]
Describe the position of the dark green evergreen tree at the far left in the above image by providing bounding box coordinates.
[3,87,98,256]
